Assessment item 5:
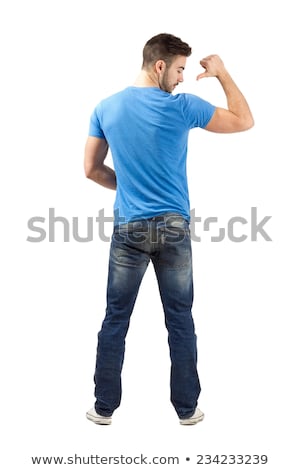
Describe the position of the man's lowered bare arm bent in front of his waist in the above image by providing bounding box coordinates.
[84,137,117,189]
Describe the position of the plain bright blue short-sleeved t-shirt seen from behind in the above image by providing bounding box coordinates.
[89,86,215,223]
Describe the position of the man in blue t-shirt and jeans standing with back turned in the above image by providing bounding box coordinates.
[85,34,253,425]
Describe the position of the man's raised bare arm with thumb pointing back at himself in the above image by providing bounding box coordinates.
[197,55,254,133]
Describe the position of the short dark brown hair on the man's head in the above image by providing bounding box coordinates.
[143,33,192,68]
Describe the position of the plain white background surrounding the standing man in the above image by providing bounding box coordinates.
[0,0,299,470]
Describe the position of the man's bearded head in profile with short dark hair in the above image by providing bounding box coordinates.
[142,33,192,93]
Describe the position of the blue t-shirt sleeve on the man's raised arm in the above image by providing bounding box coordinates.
[183,93,216,129]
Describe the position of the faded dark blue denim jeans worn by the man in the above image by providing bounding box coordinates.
[94,213,201,419]
